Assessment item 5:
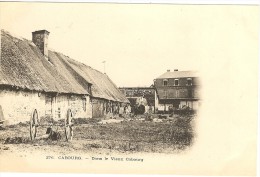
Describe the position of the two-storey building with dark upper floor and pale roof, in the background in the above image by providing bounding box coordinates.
[154,69,200,112]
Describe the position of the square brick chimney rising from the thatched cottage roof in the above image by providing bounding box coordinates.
[32,30,50,58]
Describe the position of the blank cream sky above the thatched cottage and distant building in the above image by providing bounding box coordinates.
[0,3,254,87]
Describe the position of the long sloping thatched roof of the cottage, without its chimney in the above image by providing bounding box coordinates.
[0,30,128,102]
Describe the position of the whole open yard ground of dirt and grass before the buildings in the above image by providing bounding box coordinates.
[0,116,195,157]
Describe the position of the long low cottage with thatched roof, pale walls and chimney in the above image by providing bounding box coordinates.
[0,30,128,124]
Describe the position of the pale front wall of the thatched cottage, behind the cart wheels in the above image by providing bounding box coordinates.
[0,89,92,124]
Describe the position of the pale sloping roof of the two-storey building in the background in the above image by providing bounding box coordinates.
[157,71,199,79]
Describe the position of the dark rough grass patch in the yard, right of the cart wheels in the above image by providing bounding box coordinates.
[74,116,194,151]
